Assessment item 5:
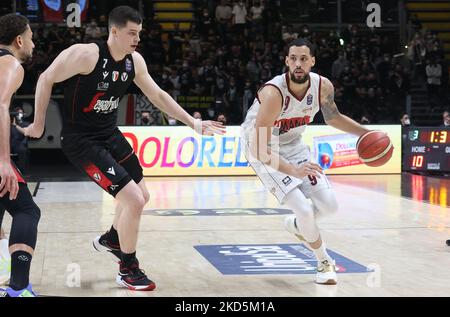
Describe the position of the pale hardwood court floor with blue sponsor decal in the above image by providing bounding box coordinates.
[0,174,450,297]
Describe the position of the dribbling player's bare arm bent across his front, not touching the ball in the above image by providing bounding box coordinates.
[250,86,322,178]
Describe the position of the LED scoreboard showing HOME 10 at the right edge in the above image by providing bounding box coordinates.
[403,127,450,172]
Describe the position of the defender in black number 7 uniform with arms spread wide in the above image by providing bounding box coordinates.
[26,6,224,290]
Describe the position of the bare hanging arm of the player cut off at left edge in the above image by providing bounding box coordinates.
[0,56,24,199]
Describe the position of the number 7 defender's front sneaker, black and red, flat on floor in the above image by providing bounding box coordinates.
[116,260,156,291]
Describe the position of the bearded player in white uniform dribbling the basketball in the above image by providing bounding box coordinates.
[242,39,368,284]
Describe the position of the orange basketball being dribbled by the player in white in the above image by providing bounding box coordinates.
[356,130,394,167]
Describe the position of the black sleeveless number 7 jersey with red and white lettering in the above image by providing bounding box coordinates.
[61,42,135,135]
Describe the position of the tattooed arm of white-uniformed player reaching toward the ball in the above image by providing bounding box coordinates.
[320,77,369,136]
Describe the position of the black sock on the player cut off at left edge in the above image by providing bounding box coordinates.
[9,251,32,291]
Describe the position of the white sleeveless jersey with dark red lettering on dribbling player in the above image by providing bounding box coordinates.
[241,72,321,145]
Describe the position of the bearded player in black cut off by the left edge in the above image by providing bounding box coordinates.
[0,14,40,297]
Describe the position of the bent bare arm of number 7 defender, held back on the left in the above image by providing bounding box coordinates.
[25,44,98,138]
